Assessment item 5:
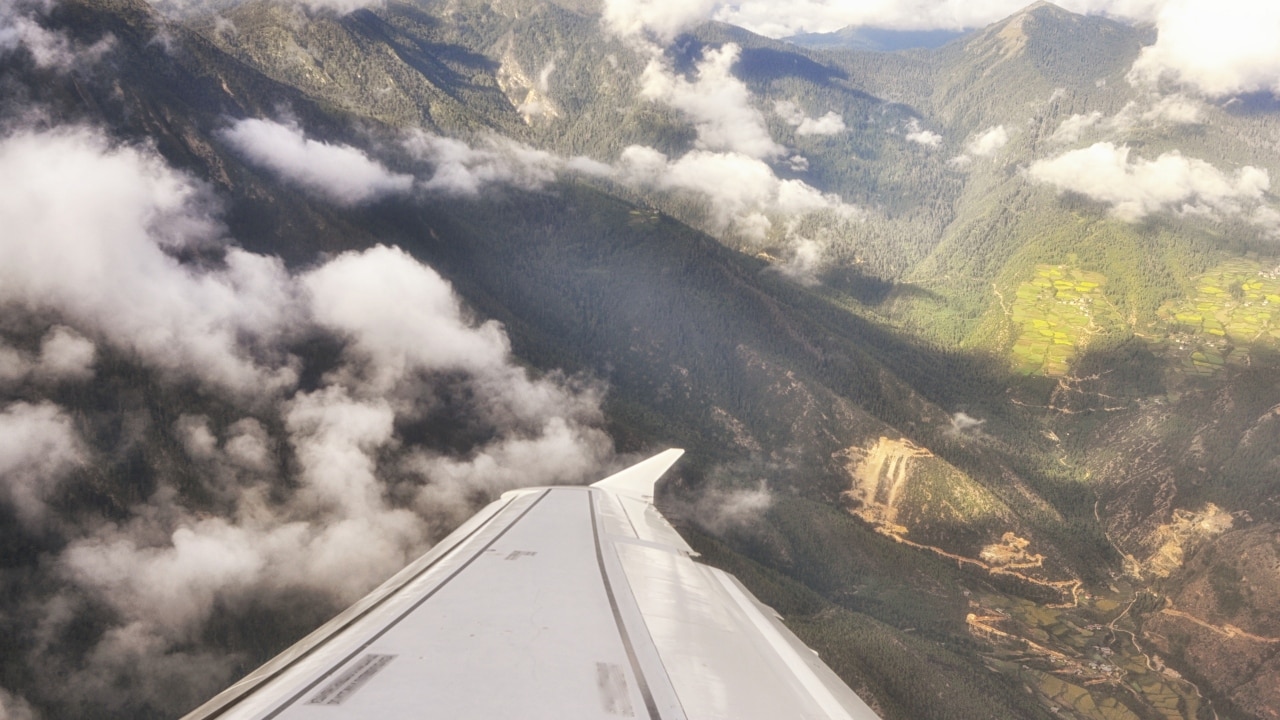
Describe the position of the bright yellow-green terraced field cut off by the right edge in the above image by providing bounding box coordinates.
[1156,259,1280,377]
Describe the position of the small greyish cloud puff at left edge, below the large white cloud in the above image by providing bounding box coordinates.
[0,402,86,527]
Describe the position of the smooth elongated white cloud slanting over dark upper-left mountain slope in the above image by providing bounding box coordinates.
[218,118,413,206]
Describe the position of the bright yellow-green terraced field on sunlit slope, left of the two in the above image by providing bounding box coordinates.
[1009,265,1123,377]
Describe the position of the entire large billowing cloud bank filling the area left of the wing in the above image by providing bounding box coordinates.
[0,127,612,716]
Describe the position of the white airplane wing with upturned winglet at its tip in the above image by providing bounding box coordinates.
[186,450,877,720]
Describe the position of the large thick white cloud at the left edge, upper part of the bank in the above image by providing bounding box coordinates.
[0,127,296,392]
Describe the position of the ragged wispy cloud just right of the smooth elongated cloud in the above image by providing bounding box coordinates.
[402,129,563,197]
